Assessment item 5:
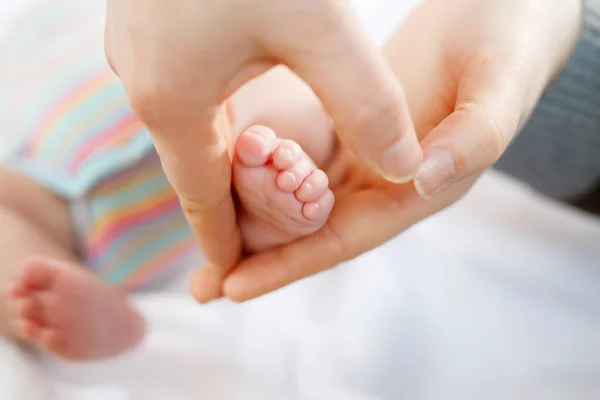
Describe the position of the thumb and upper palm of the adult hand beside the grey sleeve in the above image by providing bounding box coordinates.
[398,0,581,197]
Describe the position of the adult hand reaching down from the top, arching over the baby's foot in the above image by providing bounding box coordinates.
[106,0,422,275]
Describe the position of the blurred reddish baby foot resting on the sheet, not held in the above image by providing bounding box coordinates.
[9,261,145,361]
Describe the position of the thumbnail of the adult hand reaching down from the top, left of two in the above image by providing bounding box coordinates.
[379,135,423,184]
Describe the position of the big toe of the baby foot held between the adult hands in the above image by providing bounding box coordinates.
[235,126,277,167]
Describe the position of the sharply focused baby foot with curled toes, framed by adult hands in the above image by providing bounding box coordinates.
[233,126,334,252]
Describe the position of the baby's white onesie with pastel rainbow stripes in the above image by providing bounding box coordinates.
[0,1,200,290]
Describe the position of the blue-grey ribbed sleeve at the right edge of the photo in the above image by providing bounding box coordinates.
[496,0,600,200]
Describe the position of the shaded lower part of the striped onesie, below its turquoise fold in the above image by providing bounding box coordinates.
[81,152,198,290]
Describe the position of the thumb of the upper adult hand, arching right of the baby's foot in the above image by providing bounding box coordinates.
[265,1,422,183]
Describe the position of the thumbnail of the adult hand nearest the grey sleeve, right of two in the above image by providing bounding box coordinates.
[414,148,456,199]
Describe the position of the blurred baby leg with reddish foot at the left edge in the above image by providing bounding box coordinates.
[0,169,144,360]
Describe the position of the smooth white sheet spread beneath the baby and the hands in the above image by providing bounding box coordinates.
[0,0,600,400]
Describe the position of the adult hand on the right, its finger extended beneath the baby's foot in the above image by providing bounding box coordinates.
[195,0,581,300]
